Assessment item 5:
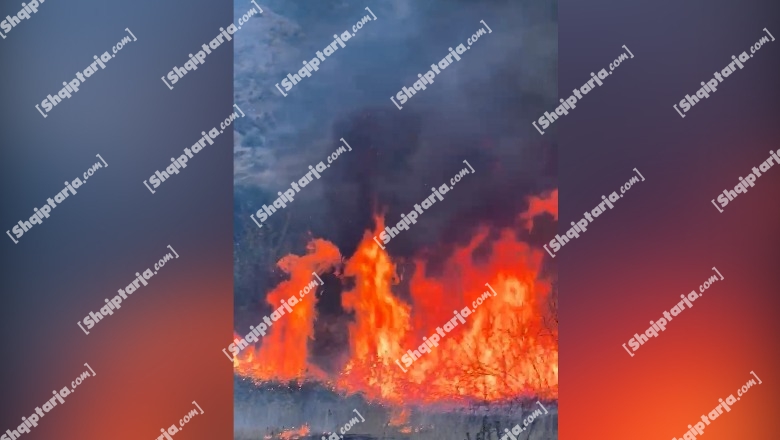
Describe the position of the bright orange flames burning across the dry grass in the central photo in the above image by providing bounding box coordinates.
[234,191,558,406]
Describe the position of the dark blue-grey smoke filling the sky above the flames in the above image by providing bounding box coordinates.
[230,0,557,340]
